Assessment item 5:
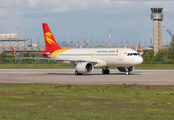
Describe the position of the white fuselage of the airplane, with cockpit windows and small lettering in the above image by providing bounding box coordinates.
[55,48,143,67]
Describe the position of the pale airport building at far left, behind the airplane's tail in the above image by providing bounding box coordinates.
[0,33,29,47]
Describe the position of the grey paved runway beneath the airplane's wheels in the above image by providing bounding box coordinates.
[0,69,174,85]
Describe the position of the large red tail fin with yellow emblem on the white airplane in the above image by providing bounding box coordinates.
[42,23,62,50]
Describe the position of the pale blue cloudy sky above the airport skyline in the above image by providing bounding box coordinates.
[0,0,174,42]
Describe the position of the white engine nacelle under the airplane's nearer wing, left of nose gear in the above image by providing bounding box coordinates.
[76,62,94,73]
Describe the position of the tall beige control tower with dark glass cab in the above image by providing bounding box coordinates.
[151,7,163,54]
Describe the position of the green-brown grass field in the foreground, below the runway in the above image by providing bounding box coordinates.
[0,83,174,120]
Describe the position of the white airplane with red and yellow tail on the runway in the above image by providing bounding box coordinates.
[11,23,143,75]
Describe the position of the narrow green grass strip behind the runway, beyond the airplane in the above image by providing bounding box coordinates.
[0,63,174,69]
